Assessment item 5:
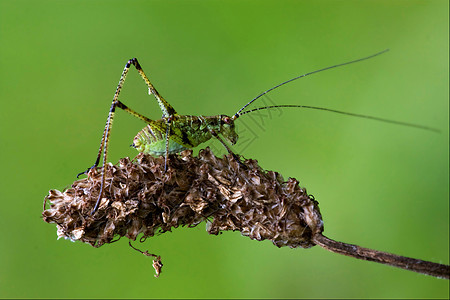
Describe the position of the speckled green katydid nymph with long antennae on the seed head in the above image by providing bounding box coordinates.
[78,49,437,214]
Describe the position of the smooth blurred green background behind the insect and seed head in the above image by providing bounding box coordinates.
[0,0,449,298]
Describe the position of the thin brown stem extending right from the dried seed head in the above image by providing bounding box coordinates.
[313,233,450,279]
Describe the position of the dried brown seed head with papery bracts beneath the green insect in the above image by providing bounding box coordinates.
[42,148,323,248]
